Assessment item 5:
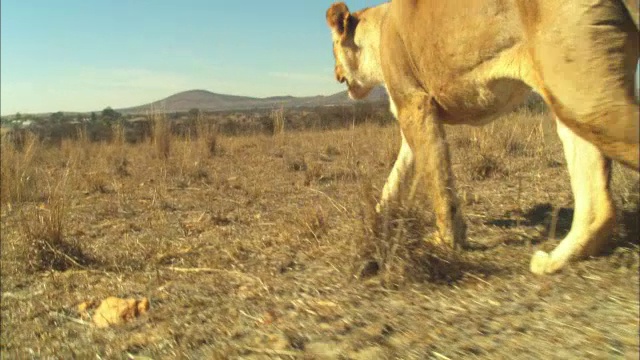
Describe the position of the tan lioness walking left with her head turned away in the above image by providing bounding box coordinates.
[326,0,640,274]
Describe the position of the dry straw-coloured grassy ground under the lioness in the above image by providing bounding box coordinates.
[0,113,640,360]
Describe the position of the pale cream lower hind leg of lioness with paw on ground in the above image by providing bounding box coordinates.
[531,120,615,274]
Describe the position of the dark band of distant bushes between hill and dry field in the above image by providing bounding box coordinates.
[3,103,395,144]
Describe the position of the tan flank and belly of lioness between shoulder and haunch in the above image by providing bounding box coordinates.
[392,0,529,124]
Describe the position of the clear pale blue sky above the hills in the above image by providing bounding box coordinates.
[0,0,384,115]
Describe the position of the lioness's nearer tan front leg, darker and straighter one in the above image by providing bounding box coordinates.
[398,94,466,248]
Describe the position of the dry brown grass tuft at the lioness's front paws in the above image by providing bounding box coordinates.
[353,172,470,286]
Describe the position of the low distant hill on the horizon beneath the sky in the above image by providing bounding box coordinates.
[116,87,387,114]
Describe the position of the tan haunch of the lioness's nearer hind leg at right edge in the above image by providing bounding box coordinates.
[531,0,640,171]
